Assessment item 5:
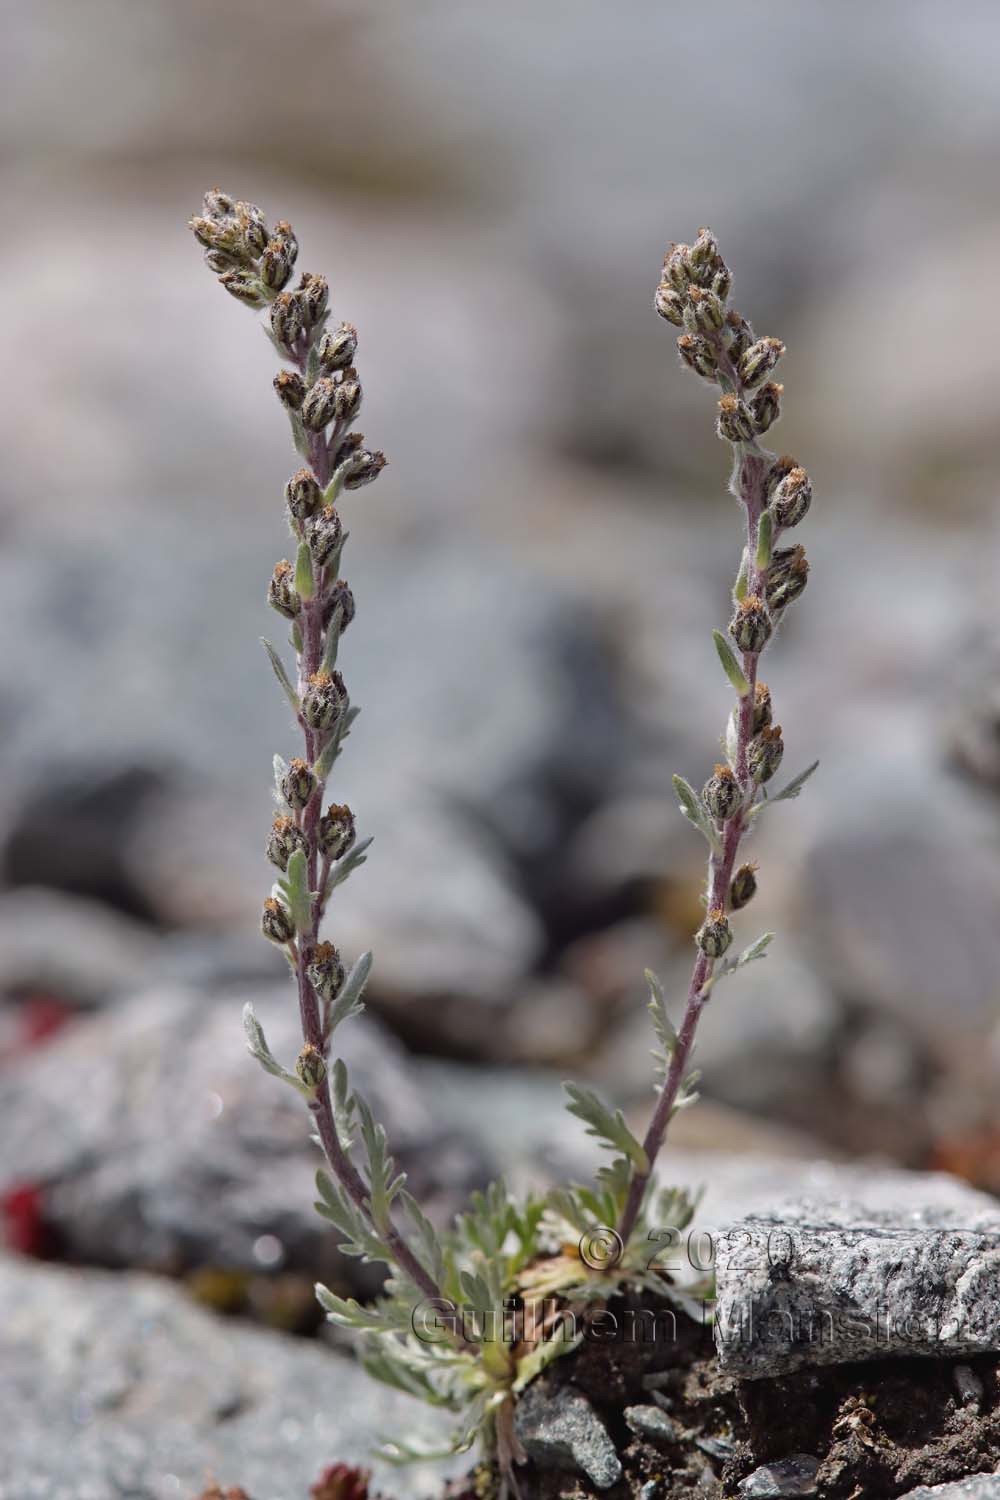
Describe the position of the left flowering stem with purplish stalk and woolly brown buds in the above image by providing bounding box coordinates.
[190,189,452,1320]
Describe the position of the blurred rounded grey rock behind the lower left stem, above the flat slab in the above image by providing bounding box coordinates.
[0,986,440,1275]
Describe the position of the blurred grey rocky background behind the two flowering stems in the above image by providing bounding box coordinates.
[0,0,1000,1500]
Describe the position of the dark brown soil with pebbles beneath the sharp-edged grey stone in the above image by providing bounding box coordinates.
[450,1296,1000,1500]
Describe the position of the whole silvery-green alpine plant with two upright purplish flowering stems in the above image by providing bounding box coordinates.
[190,191,810,1496]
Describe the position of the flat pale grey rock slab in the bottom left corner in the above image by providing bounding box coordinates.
[0,1260,466,1500]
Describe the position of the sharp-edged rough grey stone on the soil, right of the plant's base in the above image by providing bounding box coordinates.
[715,1175,1000,1379]
